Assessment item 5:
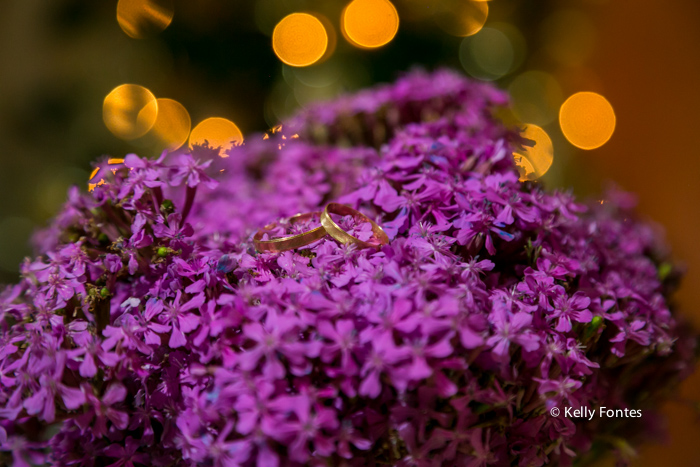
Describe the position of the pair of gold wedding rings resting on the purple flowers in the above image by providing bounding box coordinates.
[253,203,389,252]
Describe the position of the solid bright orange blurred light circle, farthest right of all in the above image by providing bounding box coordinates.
[559,92,615,149]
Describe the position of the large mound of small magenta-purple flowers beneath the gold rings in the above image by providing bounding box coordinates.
[0,71,696,467]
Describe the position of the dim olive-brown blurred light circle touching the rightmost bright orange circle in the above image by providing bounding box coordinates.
[508,71,564,126]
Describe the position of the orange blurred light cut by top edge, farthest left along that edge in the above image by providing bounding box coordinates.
[117,0,174,39]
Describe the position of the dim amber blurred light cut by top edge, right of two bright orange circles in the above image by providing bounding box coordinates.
[434,0,489,37]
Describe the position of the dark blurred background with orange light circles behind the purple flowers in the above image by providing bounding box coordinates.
[0,0,700,466]
